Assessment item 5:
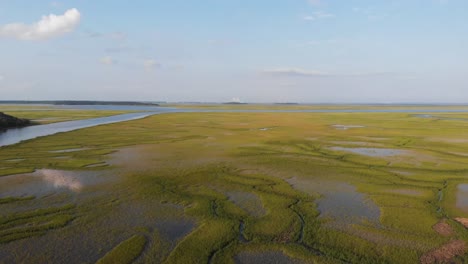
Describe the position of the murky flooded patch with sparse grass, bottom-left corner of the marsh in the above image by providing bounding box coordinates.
[0,200,195,263]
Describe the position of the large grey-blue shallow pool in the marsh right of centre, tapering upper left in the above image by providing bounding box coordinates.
[287,177,380,225]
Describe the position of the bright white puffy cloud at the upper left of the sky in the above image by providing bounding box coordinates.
[0,8,81,40]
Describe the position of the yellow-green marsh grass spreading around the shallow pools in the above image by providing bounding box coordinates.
[0,111,468,263]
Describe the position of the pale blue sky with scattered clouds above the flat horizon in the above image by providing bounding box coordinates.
[0,0,468,103]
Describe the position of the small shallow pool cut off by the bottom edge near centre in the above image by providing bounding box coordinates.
[234,251,304,264]
